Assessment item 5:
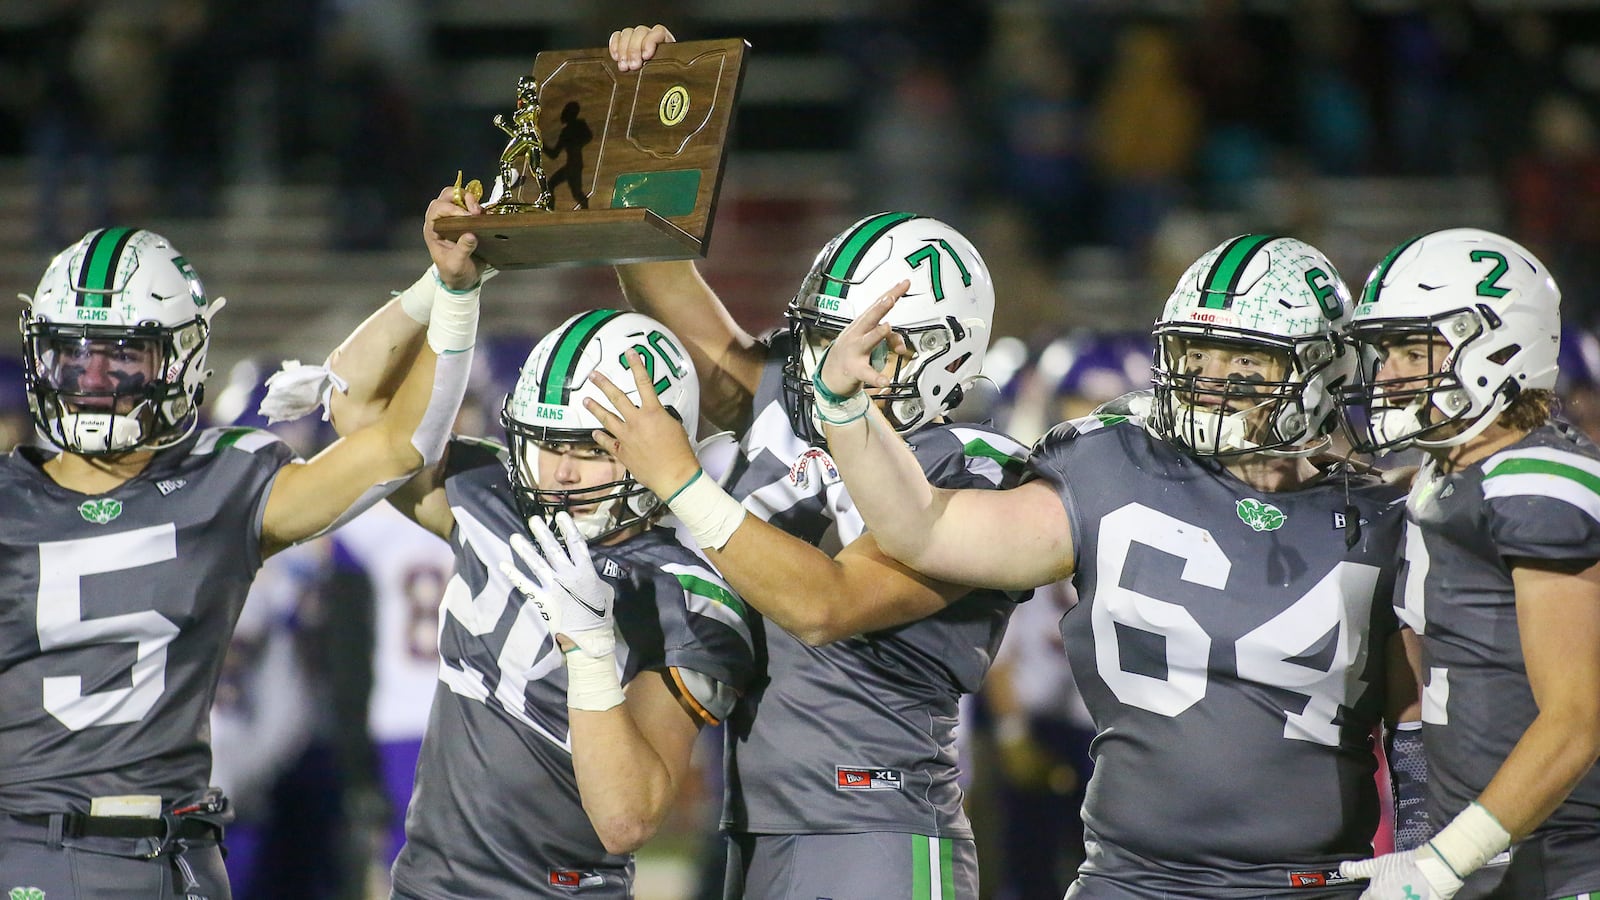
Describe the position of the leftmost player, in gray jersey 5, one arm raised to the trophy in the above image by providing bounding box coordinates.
[0,192,478,900]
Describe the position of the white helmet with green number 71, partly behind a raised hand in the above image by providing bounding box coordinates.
[784,213,995,442]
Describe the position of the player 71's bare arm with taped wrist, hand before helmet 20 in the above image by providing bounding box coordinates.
[589,350,970,645]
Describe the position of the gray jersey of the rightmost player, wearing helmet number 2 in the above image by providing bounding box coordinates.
[1397,424,1600,898]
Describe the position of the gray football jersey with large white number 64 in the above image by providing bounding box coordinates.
[1029,415,1403,897]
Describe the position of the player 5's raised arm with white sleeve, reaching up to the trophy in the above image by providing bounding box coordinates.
[262,191,478,554]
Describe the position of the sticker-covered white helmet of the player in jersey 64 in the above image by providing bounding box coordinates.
[1146,234,1355,456]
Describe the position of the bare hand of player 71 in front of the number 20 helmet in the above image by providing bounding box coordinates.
[584,351,699,500]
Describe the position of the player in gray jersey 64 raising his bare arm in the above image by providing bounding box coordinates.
[813,234,1414,900]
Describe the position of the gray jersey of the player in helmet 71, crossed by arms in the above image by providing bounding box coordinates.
[723,341,1026,838]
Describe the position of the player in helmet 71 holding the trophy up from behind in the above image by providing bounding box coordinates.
[597,26,1022,898]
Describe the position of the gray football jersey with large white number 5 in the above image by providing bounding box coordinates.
[0,429,293,812]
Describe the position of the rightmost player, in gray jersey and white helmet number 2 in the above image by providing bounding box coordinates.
[1344,229,1600,900]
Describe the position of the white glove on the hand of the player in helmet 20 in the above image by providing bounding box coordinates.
[501,509,616,657]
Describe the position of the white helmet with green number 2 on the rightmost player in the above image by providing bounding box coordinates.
[1341,227,1562,452]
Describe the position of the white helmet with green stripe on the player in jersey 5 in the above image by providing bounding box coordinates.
[21,227,224,456]
